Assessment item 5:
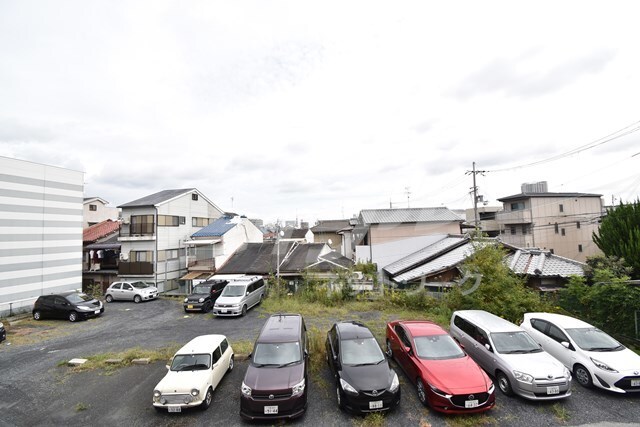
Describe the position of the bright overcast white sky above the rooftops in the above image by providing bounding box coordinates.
[0,0,640,224]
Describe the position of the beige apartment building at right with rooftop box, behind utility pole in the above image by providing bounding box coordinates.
[496,182,605,262]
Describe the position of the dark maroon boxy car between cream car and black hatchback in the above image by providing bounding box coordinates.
[240,314,309,420]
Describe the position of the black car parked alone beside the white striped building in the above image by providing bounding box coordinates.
[31,292,104,322]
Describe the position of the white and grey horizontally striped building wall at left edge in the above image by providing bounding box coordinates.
[0,157,84,315]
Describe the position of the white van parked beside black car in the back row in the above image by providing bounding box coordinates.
[213,276,266,316]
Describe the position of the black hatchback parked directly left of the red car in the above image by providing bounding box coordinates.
[326,322,400,414]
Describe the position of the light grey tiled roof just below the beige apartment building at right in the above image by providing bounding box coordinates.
[506,249,586,277]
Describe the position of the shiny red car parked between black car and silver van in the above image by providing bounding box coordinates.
[386,320,496,414]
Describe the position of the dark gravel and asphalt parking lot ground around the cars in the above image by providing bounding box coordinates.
[0,298,640,426]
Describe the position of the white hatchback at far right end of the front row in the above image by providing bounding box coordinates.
[520,313,640,393]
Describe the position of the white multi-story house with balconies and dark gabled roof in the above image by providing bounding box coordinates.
[118,188,223,292]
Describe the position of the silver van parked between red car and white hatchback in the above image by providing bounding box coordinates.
[449,310,571,400]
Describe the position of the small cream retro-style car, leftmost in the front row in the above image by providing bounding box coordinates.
[153,335,233,412]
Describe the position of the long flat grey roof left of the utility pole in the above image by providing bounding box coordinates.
[360,207,462,224]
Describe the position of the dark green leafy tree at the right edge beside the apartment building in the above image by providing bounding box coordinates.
[593,199,640,278]
